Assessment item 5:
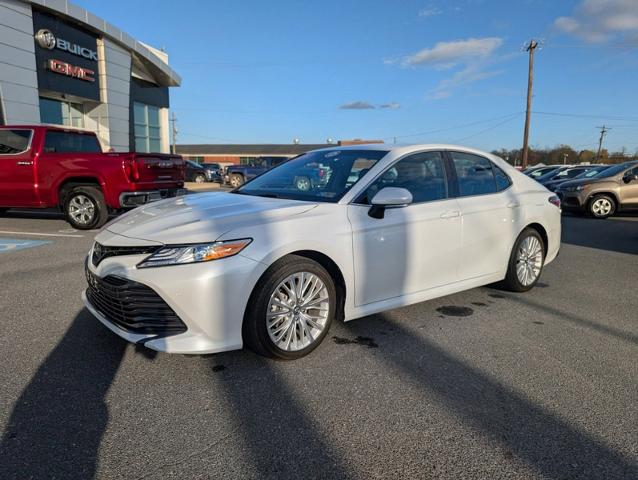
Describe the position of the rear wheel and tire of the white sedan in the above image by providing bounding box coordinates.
[500,227,546,292]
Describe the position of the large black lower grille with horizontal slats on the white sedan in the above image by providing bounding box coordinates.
[86,268,187,336]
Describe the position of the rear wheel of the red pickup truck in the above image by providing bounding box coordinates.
[64,186,109,230]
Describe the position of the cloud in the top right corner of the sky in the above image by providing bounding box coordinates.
[554,0,638,42]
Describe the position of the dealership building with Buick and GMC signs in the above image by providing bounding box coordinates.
[0,0,181,152]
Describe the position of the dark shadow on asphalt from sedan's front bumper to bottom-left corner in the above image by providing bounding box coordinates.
[0,309,127,479]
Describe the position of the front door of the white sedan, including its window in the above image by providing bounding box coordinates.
[348,151,461,306]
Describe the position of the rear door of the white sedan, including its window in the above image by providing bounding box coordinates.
[449,151,521,280]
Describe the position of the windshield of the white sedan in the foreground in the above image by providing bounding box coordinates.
[235,149,388,203]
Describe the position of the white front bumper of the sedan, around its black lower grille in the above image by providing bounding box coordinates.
[82,238,266,354]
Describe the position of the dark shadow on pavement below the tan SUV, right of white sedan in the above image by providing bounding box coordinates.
[561,216,638,255]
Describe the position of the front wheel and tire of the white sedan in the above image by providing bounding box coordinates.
[242,255,337,360]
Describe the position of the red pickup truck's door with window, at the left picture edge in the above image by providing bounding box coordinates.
[0,128,40,207]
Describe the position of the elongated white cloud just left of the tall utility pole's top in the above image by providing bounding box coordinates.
[403,37,503,68]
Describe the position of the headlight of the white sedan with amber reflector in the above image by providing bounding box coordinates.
[137,238,253,268]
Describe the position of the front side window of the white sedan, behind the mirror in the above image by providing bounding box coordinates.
[357,152,448,204]
